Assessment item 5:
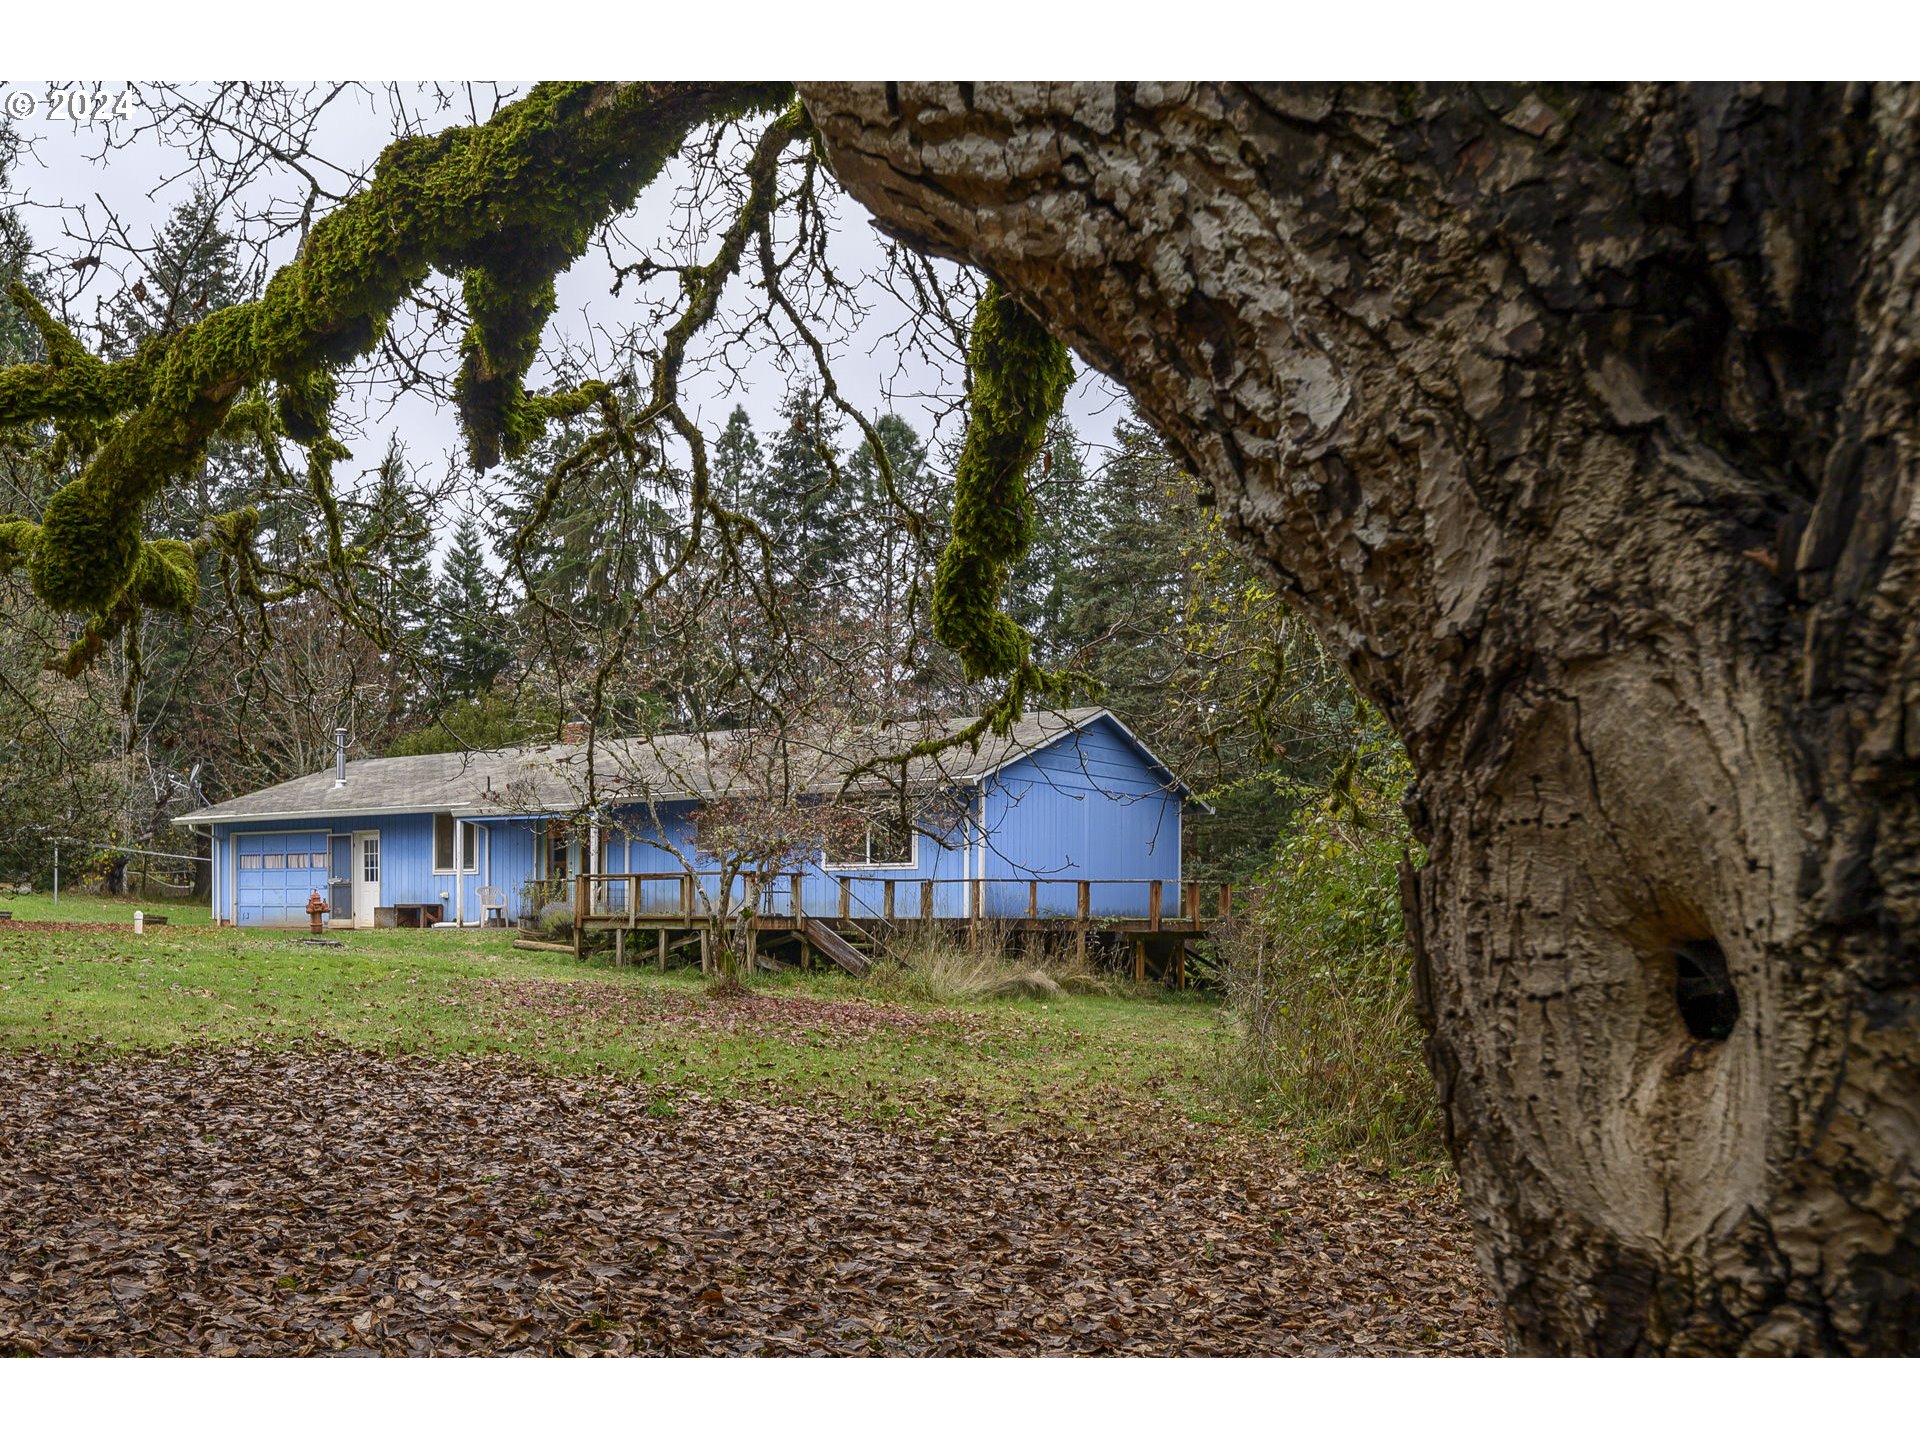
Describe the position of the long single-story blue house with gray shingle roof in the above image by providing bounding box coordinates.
[175,708,1198,929]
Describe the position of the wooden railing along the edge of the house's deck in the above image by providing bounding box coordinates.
[572,870,1233,929]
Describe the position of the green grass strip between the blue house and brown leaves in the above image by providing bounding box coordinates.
[0,897,1238,1125]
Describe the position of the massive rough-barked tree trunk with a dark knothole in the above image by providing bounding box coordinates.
[803,84,1920,1352]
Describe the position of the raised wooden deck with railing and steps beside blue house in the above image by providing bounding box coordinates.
[572,872,1233,987]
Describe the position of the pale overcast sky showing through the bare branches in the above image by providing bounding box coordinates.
[0,81,1123,549]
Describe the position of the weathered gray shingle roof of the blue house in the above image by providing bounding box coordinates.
[175,707,1188,826]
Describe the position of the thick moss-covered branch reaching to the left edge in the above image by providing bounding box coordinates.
[0,84,791,633]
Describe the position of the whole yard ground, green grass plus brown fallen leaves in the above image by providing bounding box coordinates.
[0,897,1498,1354]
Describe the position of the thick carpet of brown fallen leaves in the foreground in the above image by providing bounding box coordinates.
[0,1048,1498,1356]
